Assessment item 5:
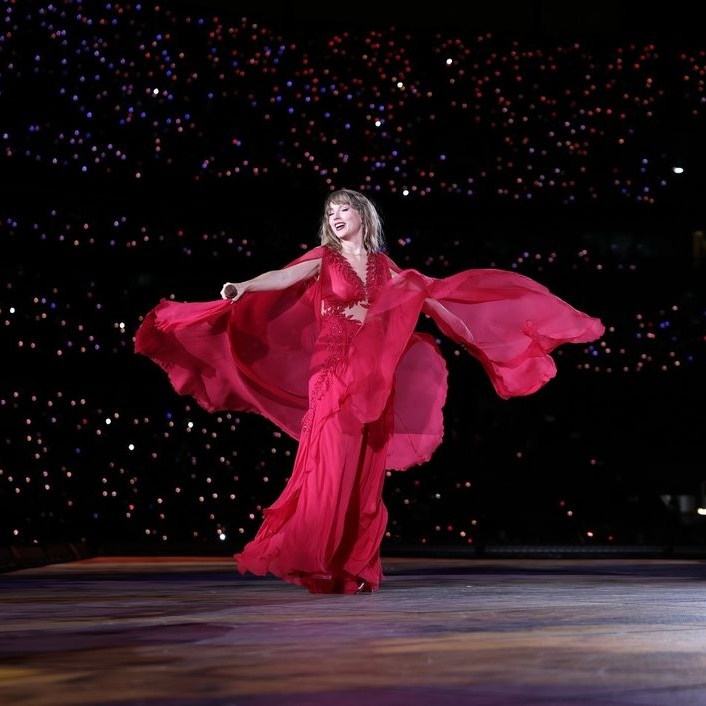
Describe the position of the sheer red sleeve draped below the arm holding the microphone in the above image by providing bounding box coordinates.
[135,247,322,439]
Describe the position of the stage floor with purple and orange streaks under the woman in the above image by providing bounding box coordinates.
[0,557,706,706]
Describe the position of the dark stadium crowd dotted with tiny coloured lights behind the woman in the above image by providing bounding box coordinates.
[0,0,706,552]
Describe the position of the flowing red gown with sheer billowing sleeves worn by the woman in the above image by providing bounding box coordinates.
[135,246,604,592]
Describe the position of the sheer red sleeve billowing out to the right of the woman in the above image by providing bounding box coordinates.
[340,262,604,434]
